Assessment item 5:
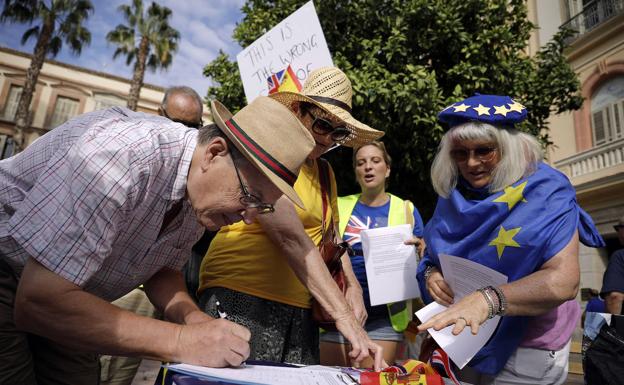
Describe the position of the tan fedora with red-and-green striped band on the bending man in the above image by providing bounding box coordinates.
[210,96,315,208]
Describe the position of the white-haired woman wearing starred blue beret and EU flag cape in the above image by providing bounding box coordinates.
[417,94,604,384]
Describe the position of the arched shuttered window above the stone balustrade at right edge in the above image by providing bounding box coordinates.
[591,76,624,146]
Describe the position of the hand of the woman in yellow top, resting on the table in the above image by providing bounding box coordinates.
[336,312,388,371]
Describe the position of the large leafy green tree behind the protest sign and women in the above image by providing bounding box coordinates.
[204,0,582,217]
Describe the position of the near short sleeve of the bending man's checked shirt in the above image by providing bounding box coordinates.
[11,132,142,285]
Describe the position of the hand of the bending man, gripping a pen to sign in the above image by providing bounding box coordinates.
[175,319,251,368]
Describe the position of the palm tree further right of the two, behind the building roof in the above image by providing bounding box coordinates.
[106,0,180,111]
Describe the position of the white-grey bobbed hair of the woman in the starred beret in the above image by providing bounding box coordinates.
[431,122,544,198]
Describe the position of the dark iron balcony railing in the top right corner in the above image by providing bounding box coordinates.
[560,0,624,44]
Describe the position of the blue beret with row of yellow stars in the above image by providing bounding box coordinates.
[438,94,527,127]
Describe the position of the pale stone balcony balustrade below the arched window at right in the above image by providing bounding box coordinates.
[555,138,624,178]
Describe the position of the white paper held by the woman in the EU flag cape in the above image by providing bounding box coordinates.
[416,254,507,369]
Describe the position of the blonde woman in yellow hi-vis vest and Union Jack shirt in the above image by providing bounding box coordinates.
[321,141,424,367]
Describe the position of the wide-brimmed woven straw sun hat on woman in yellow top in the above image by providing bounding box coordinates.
[269,67,384,147]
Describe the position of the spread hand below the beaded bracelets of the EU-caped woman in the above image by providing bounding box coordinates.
[418,291,489,335]
